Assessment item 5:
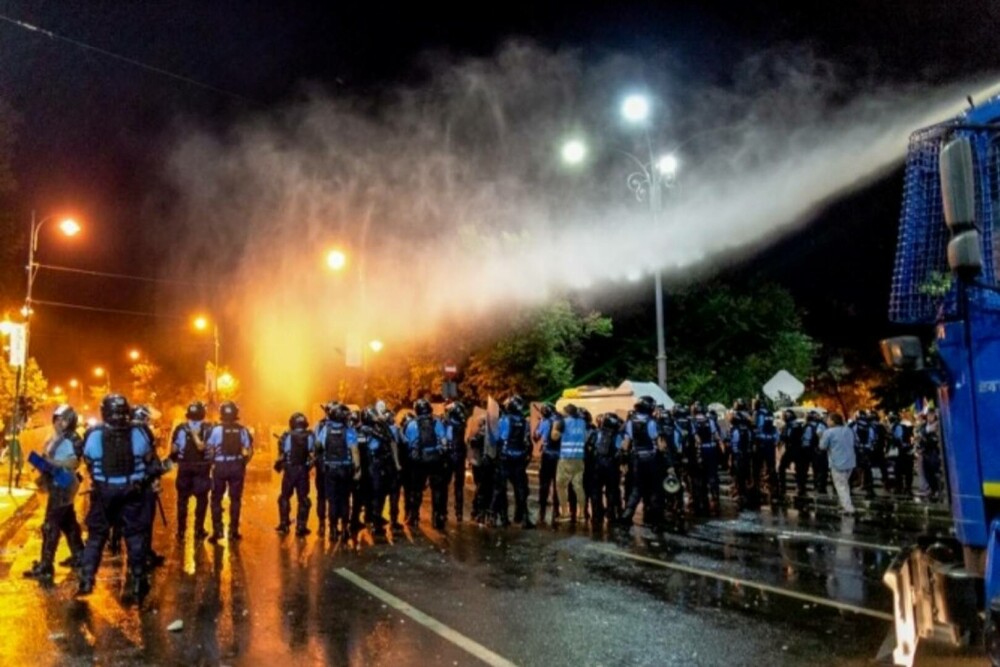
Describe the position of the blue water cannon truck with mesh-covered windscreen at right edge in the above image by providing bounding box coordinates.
[881,96,1000,666]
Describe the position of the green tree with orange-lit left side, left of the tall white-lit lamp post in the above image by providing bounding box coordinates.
[462,299,612,400]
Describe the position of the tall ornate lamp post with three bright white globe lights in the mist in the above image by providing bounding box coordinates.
[562,95,679,391]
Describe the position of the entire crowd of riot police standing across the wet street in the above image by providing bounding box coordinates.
[19,394,941,599]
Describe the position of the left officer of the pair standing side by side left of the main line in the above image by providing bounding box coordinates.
[170,401,212,540]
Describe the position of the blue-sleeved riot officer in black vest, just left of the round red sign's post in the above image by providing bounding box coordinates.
[405,398,449,530]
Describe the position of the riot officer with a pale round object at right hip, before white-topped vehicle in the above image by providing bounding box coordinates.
[620,396,674,531]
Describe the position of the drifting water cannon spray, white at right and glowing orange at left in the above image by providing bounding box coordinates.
[169,43,1000,410]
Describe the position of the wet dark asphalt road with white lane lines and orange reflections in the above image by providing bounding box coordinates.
[0,464,985,667]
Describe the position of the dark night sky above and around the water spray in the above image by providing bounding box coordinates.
[0,0,1000,392]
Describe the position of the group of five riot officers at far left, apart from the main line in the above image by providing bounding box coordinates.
[24,394,253,600]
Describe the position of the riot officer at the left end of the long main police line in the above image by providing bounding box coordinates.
[274,412,316,537]
